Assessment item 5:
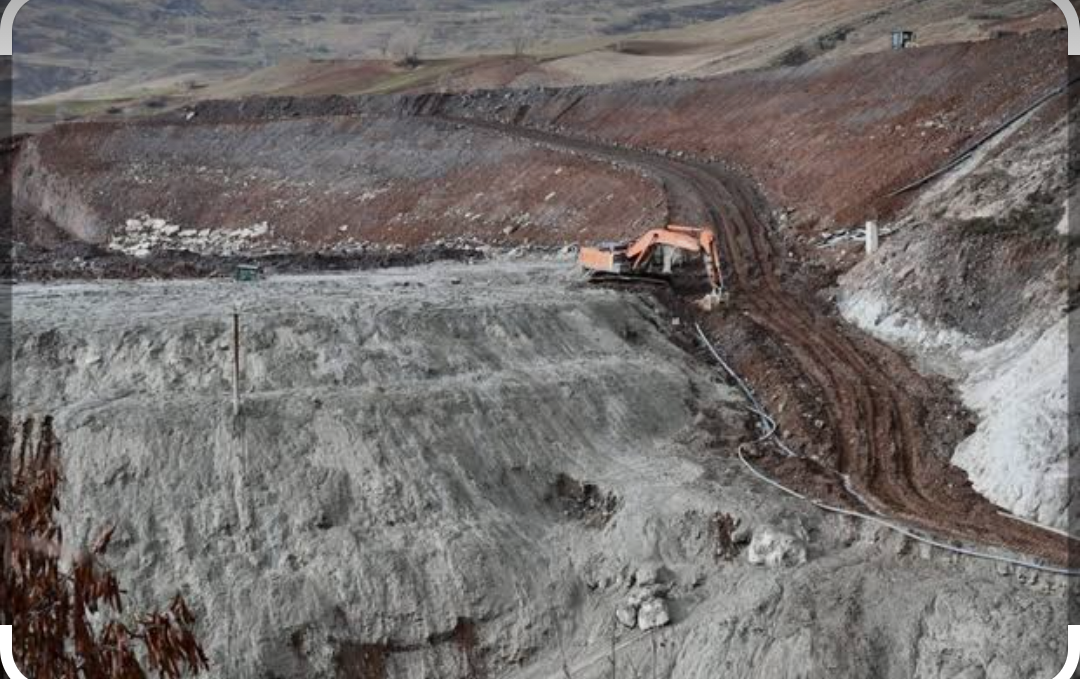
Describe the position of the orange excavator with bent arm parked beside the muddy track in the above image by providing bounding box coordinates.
[578,225,724,298]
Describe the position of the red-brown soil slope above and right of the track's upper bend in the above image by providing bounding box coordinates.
[427,31,1067,232]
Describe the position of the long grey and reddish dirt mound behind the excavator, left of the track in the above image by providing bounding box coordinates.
[15,117,664,256]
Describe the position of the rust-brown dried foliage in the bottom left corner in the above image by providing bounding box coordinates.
[0,418,207,679]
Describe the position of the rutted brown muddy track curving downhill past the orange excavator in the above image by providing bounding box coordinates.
[444,113,1076,565]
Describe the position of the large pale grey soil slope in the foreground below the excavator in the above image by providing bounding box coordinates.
[15,260,1065,679]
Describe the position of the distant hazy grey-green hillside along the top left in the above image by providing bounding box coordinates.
[15,0,774,98]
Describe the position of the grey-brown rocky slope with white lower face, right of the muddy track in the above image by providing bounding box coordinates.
[840,85,1076,529]
